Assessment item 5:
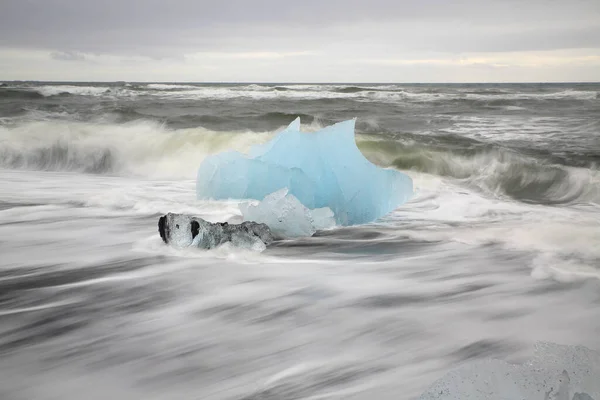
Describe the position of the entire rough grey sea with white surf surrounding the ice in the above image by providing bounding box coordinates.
[0,82,600,400]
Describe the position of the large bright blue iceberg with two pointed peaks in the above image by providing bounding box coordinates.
[196,118,413,225]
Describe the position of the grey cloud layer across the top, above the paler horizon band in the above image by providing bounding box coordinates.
[0,0,600,57]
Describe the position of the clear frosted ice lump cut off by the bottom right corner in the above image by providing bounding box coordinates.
[419,343,600,400]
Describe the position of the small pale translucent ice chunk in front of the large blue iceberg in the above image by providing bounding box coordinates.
[240,188,335,238]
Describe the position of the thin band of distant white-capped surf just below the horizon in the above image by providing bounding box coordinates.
[0,83,598,106]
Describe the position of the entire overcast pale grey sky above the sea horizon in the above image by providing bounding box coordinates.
[0,0,600,82]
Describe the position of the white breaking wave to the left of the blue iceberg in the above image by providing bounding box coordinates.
[0,120,272,179]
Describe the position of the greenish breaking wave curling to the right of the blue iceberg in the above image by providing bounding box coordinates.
[359,141,600,204]
